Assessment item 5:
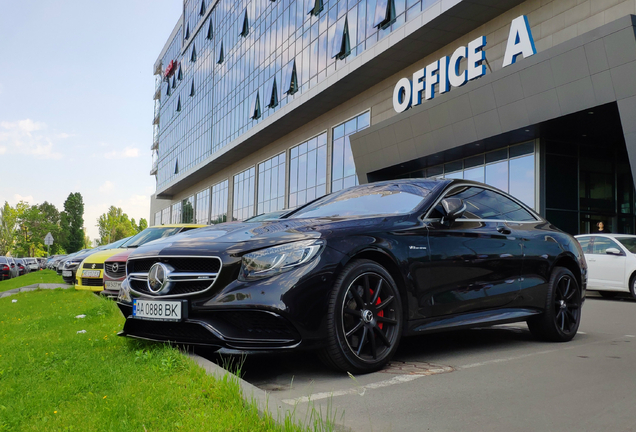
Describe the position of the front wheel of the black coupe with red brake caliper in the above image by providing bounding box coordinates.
[319,260,403,373]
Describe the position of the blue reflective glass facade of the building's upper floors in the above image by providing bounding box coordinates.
[156,0,441,188]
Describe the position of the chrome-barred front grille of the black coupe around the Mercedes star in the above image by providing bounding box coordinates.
[126,256,222,297]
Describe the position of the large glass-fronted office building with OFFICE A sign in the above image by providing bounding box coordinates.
[149,0,636,233]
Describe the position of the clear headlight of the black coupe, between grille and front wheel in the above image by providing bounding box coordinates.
[239,240,324,281]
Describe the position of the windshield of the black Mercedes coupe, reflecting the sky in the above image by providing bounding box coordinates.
[290,183,430,219]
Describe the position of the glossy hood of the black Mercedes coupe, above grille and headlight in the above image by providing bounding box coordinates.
[130,217,398,258]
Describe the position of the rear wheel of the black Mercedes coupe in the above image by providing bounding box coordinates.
[528,267,582,342]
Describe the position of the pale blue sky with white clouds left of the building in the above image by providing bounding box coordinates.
[0,0,183,238]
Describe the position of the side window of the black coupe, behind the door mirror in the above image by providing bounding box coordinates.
[431,186,536,222]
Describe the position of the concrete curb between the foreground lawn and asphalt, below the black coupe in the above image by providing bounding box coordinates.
[190,354,351,432]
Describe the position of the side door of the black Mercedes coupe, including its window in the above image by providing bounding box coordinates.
[414,185,523,316]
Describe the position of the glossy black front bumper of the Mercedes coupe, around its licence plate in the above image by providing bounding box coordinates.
[117,248,343,350]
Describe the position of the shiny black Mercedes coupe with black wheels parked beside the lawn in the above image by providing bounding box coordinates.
[118,179,587,373]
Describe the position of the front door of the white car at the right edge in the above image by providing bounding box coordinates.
[585,236,627,291]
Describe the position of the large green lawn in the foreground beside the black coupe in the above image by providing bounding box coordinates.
[0,289,331,432]
